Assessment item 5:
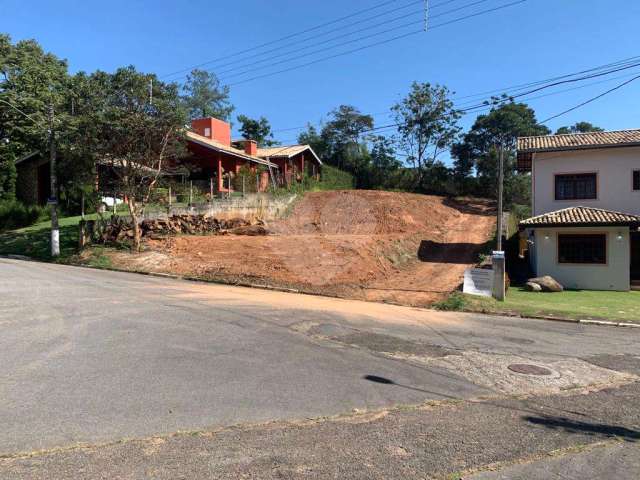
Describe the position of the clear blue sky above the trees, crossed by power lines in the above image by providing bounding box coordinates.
[0,0,640,155]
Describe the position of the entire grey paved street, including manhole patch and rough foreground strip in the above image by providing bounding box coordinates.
[0,259,640,478]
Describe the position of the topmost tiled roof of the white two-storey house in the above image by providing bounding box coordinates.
[518,129,640,152]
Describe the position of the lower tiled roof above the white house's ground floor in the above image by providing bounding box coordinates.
[520,207,640,227]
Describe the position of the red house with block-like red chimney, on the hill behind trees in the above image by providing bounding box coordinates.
[181,117,322,193]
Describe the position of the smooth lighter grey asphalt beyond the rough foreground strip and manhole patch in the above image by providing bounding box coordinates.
[0,259,640,454]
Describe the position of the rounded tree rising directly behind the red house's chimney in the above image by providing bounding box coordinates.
[183,69,234,121]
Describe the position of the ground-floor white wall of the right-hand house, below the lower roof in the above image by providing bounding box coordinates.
[535,227,631,291]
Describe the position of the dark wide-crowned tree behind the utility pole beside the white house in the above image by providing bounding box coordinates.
[451,99,549,204]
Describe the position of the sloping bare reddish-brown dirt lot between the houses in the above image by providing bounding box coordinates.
[107,191,495,306]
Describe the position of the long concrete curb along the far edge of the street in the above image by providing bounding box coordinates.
[0,254,640,328]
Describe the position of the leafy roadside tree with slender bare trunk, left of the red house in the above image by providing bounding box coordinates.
[80,67,186,250]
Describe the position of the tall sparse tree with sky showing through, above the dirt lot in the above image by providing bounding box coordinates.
[391,82,461,188]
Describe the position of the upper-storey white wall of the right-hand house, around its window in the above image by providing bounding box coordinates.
[532,147,640,216]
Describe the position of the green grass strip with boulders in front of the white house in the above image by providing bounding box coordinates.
[435,288,640,322]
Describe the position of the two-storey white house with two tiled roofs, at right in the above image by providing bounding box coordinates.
[518,130,640,290]
